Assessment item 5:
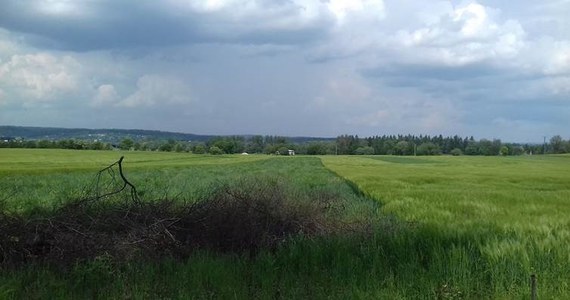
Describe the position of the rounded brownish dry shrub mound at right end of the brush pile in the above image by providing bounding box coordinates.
[178,181,335,252]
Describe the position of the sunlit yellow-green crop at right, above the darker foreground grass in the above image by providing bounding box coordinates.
[323,156,570,231]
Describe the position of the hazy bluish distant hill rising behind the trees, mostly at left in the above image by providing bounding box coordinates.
[0,126,334,143]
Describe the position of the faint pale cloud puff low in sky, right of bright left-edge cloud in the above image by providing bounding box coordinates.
[117,75,190,108]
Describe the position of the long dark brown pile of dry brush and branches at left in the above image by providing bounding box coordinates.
[0,161,369,267]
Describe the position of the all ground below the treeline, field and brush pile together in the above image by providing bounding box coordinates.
[0,150,570,299]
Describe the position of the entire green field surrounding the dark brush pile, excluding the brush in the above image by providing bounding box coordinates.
[0,149,570,299]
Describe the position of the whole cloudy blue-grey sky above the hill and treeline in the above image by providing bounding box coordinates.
[0,0,570,142]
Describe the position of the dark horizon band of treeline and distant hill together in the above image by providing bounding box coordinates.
[0,126,570,156]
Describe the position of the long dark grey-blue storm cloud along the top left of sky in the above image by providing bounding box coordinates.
[0,0,328,51]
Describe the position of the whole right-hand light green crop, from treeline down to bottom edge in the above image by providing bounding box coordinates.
[322,156,570,299]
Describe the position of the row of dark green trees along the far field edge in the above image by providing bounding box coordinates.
[0,135,570,156]
